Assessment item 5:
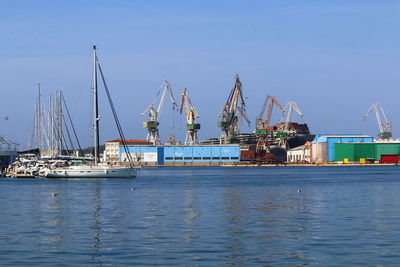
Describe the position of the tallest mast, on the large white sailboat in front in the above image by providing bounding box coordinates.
[93,45,99,165]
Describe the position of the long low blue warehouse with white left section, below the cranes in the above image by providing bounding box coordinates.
[119,145,240,166]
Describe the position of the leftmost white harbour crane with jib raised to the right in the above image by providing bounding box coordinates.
[142,79,178,145]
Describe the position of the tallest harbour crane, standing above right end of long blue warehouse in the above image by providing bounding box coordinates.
[217,74,250,143]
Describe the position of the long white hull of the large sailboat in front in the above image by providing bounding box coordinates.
[43,166,137,178]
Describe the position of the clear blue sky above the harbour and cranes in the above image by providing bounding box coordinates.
[0,0,400,149]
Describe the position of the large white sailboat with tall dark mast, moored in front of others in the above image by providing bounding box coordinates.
[42,46,139,178]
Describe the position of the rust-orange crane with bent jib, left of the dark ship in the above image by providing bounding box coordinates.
[255,95,285,157]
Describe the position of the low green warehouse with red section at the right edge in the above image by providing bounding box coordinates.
[334,141,400,163]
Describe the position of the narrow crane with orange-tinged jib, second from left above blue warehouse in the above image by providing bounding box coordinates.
[179,88,200,145]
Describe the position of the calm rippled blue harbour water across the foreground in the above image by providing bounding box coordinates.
[0,167,400,266]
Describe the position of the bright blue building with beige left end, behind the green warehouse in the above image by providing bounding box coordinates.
[311,134,374,163]
